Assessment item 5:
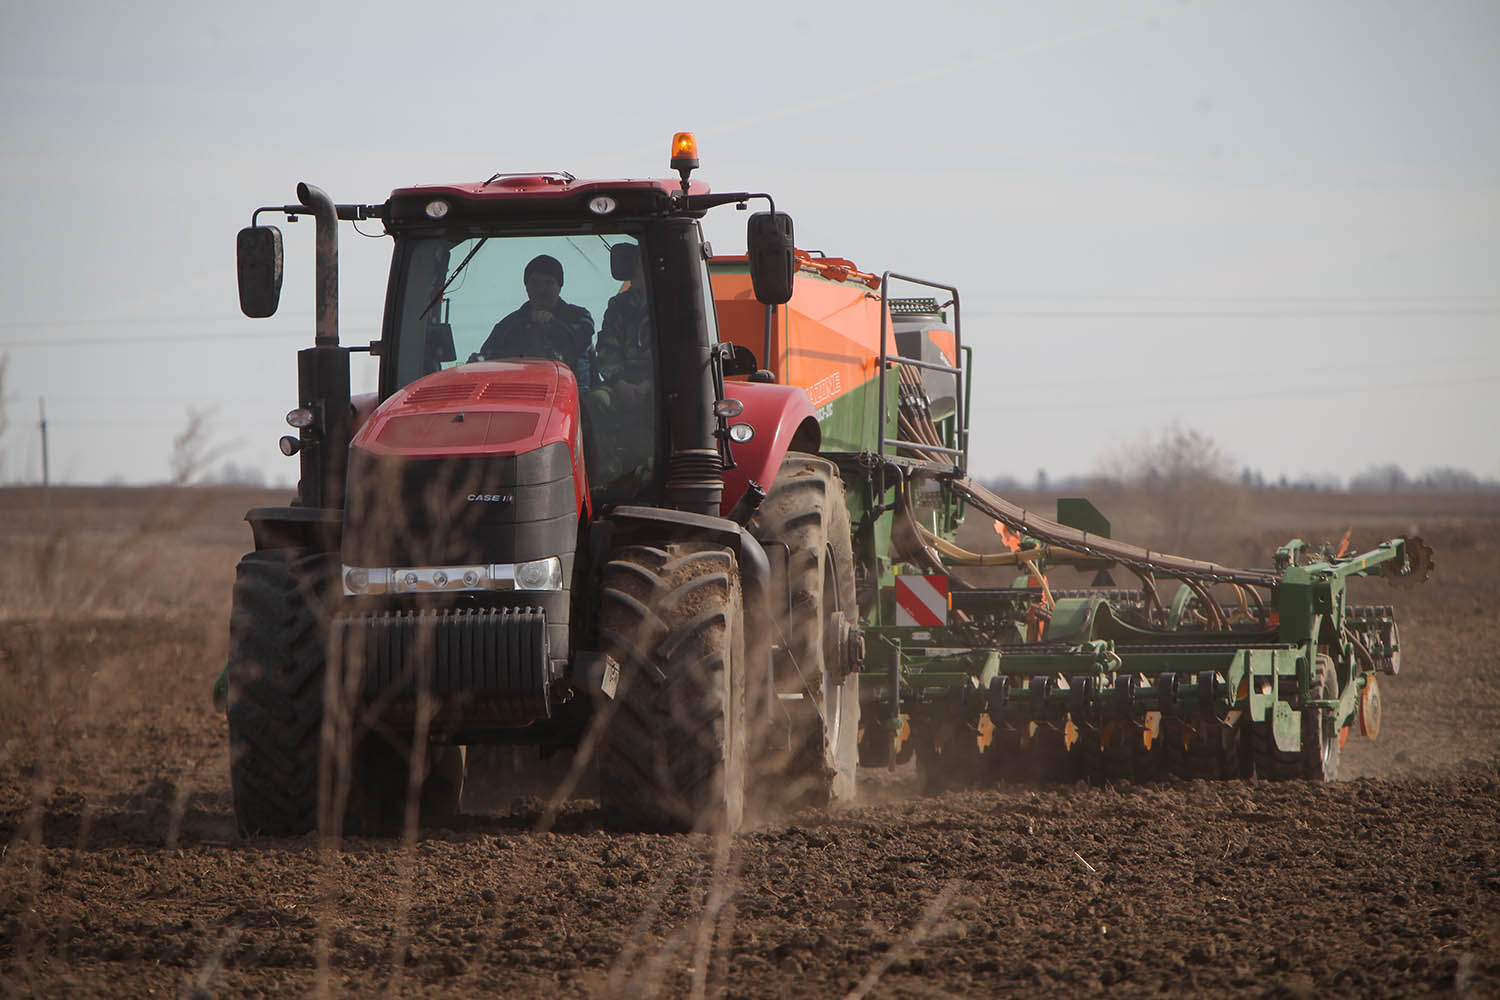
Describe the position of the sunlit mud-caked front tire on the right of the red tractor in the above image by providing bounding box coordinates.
[599,543,746,832]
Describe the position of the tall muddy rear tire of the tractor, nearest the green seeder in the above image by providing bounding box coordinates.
[750,453,860,808]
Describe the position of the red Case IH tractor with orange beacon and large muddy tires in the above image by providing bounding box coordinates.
[225,133,860,834]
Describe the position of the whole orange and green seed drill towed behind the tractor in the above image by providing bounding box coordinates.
[716,260,1433,784]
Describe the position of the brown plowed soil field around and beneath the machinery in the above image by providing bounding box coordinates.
[0,489,1500,999]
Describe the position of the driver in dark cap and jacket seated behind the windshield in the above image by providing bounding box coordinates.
[471,253,594,390]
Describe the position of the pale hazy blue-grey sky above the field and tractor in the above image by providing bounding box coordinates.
[0,0,1500,481]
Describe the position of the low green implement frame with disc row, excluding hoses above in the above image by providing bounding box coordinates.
[861,538,1430,777]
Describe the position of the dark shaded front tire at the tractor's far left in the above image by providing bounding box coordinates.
[227,549,338,837]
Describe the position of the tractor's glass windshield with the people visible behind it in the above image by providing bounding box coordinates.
[390,234,657,499]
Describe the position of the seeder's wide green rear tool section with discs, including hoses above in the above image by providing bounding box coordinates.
[864,477,1433,787]
